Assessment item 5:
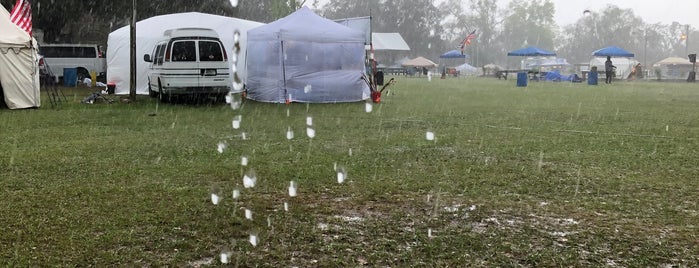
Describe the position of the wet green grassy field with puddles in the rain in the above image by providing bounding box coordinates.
[0,77,699,267]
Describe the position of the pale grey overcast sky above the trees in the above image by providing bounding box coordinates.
[306,0,699,28]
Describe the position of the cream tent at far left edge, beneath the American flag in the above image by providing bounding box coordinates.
[0,5,41,109]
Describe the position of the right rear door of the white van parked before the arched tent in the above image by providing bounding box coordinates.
[198,40,229,89]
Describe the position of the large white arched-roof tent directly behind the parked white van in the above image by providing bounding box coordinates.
[107,12,264,94]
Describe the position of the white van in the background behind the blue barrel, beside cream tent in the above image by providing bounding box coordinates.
[39,44,107,81]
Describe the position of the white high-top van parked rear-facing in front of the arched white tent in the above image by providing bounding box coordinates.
[143,28,230,101]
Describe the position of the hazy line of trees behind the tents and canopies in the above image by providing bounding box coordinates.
[0,0,699,66]
